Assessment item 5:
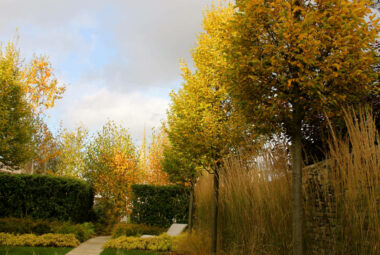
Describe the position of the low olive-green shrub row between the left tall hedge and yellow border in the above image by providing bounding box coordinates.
[0,218,95,242]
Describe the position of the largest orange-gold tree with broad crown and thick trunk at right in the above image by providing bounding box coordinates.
[194,0,380,255]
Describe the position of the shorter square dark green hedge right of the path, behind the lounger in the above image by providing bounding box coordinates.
[131,184,189,227]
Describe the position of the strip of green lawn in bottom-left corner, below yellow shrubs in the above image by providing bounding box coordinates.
[0,246,72,255]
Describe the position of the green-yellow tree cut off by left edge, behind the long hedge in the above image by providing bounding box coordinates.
[0,44,33,166]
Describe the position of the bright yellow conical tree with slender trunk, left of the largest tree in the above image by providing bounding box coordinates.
[164,4,249,235]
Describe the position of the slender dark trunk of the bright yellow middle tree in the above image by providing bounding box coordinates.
[211,169,219,255]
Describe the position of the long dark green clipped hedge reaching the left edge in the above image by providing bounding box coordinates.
[0,173,94,222]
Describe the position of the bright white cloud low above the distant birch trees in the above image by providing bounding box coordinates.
[63,88,168,139]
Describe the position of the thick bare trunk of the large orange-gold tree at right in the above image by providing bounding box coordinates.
[292,124,303,255]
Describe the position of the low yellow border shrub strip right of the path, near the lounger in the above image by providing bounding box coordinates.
[103,234,175,251]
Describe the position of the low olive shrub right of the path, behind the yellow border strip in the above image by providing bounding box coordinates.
[112,223,166,238]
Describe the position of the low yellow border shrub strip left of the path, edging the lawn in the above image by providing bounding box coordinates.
[0,233,80,247]
